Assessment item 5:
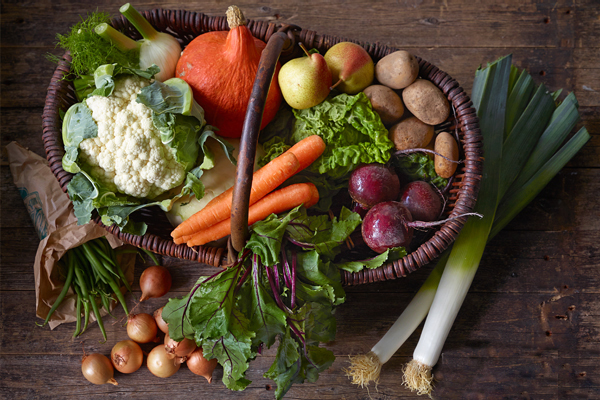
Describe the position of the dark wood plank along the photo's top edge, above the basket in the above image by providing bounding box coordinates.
[2,0,597,48]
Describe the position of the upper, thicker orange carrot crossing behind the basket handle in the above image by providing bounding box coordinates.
[171,149,300,239]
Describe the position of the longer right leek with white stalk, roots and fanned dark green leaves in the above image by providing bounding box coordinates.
[404,56,590,394]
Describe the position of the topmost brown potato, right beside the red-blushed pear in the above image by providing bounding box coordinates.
[375,50,419,89]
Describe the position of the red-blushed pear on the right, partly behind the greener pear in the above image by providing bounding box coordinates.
[325,42,375,94]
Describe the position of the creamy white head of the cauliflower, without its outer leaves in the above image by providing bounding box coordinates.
[79,75,185,199]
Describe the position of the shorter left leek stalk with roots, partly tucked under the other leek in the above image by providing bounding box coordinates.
[345,251,449,387]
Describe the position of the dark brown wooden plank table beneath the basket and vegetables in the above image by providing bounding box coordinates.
[0,0,600,399]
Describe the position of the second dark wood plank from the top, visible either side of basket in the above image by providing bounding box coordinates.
[1,44,600,111]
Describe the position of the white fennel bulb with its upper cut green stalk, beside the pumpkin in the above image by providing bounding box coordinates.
[119,3,181,82]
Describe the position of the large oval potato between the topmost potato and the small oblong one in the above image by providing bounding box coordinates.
[402,79,450,125]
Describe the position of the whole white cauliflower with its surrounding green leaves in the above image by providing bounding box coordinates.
[63,64,235,235]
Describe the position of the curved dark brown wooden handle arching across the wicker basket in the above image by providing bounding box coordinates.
[231,31,288,252]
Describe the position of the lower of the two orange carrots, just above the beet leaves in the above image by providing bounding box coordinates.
[185,183,319,247]
